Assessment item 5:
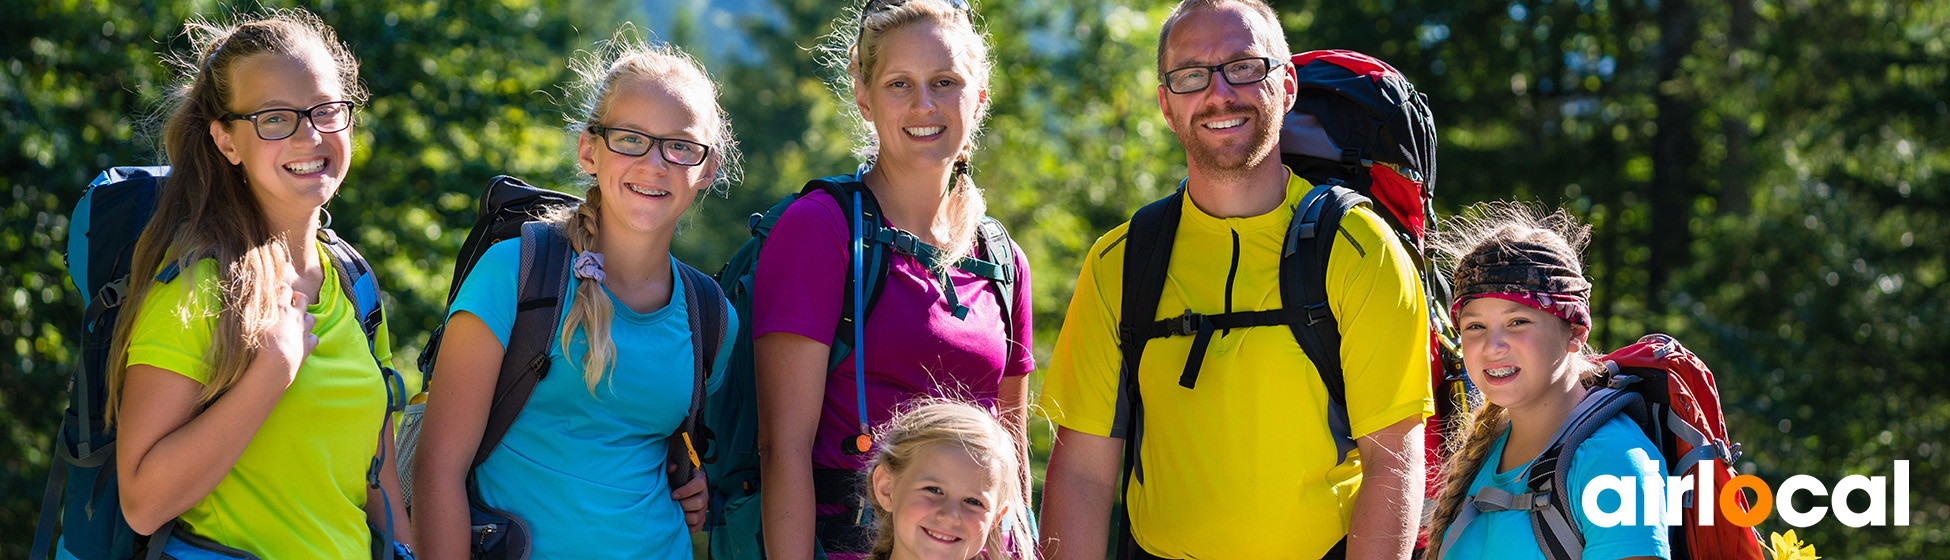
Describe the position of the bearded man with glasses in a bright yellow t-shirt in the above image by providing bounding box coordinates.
[1041,0,1433,560]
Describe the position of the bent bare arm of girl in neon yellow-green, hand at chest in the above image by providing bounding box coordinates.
[115,289,318,535]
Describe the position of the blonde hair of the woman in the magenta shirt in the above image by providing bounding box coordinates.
[821,0,995,273]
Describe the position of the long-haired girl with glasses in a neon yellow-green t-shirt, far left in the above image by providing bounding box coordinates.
[107,10,411,558]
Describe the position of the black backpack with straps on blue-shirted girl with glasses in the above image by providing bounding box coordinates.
[400,176,729,558]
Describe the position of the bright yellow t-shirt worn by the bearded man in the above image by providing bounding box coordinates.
[1041,174,1435,558]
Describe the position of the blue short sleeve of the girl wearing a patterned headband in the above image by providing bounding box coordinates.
[1568,416,1673,560]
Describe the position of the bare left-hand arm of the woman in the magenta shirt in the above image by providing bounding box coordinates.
[753,332,831,560]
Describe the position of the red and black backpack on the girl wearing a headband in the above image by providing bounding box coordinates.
[1433,334,1761,560]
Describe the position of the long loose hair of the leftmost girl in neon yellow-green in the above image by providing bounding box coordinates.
[103,8,365,425]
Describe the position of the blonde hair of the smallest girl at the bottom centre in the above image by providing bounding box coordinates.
[862,398,1035,560]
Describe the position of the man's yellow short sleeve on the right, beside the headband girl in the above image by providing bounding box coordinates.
[1328,209,1435,437]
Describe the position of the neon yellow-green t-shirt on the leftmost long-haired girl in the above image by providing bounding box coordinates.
[125,242,392,560]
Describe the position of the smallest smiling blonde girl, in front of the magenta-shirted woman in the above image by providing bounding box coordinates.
[866,400,1035,560]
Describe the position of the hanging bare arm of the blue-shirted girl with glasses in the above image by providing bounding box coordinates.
[410,312,507,560]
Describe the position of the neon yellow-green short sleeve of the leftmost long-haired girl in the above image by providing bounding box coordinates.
[125,260,218,382]
